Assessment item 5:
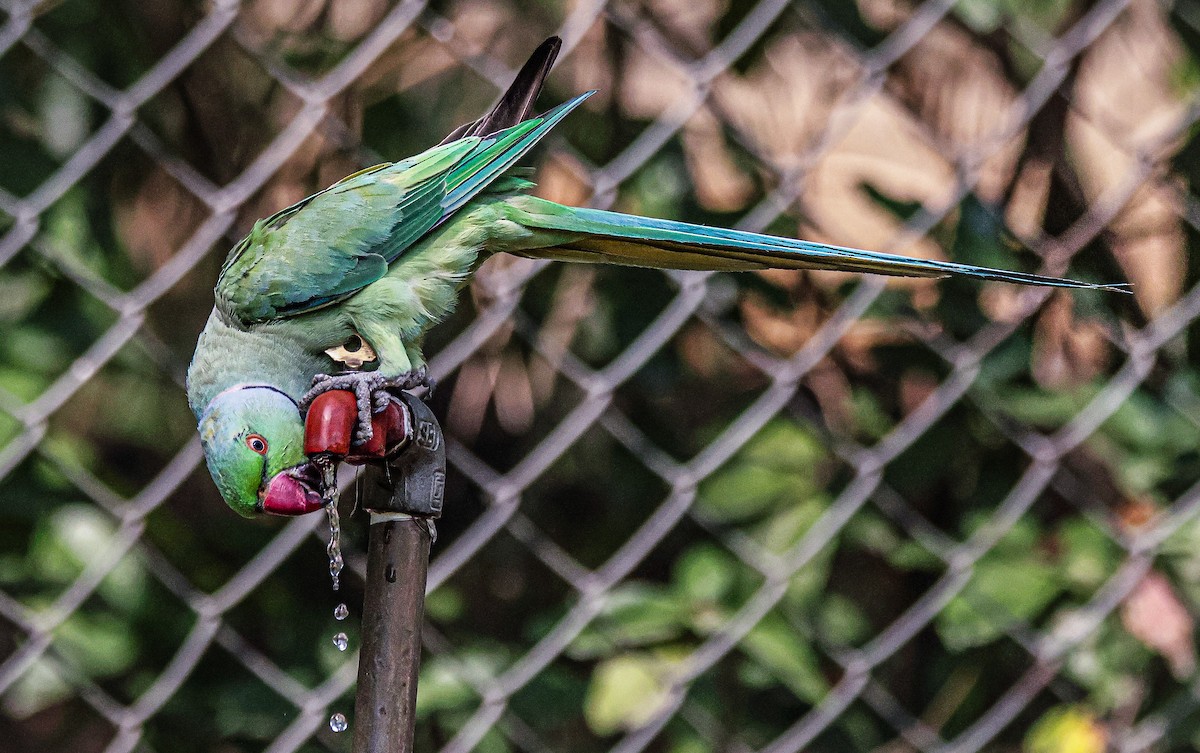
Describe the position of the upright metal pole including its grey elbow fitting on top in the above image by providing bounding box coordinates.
[354,393,445,753]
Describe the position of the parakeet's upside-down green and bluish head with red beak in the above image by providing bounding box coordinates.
[199,385,324,518]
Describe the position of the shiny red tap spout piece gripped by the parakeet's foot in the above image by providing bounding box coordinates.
[304,390,412,465]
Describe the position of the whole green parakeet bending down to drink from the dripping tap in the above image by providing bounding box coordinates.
[187,38,1121,516]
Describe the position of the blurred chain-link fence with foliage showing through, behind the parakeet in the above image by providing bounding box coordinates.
[0,0,1200,753]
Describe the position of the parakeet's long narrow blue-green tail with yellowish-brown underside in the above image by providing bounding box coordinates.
[504,197,1129,293]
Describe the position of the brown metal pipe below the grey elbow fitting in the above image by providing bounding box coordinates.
[354,513,431,753]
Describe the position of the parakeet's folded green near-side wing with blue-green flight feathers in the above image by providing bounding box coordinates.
[216,92,593,325]
